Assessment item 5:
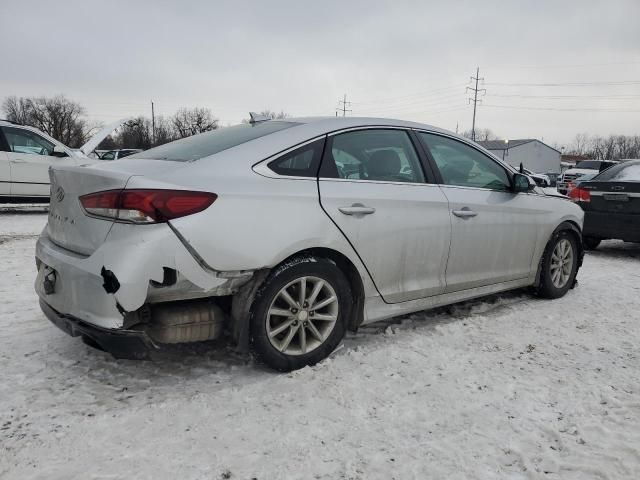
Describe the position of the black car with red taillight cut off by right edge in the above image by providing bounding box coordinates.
[569,160,640,249]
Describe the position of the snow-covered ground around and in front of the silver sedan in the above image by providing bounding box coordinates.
[0,213,640,480]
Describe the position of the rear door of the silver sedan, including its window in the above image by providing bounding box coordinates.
[318,128,451,303]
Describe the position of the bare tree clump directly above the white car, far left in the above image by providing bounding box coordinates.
[2,95,89,147]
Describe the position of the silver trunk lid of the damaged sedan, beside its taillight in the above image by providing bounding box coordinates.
[46,166,133,255]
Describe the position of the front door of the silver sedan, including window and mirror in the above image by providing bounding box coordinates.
[417,132,550,292]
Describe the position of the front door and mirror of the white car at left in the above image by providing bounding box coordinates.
[2,127,76,197]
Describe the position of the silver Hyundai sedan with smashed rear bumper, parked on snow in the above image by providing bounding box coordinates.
[35,117,583,370]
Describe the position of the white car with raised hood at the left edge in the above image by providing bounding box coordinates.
[0,120,123,203]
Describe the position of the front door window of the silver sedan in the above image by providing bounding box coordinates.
[418,132,511,191]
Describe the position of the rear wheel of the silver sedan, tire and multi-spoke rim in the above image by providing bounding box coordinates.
[250,256,353,372]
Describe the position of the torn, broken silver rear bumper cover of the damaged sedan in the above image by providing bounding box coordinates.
[35,223,253,330]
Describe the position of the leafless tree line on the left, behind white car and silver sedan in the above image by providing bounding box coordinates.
[1,95,288,150]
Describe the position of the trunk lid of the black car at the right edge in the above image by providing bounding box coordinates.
[580,181,640,214]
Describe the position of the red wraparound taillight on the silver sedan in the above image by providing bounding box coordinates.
[80,190,218,223]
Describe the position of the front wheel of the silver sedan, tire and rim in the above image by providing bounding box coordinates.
[538,230,580,298]
